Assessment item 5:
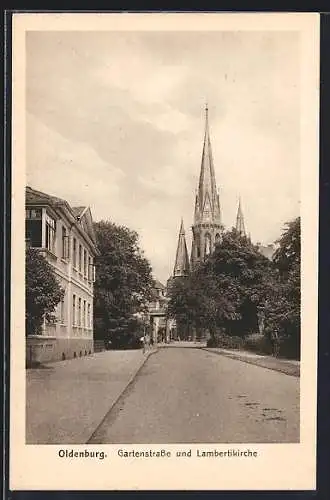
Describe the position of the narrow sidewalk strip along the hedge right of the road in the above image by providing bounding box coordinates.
[203,347,300,377]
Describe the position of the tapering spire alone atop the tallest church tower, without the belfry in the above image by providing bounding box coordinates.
[195,104,221,224]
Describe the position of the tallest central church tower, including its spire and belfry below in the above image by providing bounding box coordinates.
[191,106,222,267]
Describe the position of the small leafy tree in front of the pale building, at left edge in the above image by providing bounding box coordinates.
[25,247,64,335]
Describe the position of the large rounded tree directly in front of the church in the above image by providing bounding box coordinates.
[169,230,271,336]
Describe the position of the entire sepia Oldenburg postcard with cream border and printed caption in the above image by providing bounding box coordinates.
[10,13,320,490]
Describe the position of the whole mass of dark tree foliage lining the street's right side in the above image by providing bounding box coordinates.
[169,218,300,356]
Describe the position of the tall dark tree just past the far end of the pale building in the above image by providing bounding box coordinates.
[94,221,153,340]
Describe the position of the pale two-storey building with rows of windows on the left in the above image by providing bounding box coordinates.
[25,187,98,362]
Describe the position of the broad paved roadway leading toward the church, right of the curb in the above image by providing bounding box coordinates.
[90,347,299,444]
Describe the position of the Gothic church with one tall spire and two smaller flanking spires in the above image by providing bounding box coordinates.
[172,106,247,279]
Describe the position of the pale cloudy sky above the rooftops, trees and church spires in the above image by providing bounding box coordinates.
[26,31,301,282]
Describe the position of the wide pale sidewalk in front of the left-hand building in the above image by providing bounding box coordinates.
[26,349,156,444]
